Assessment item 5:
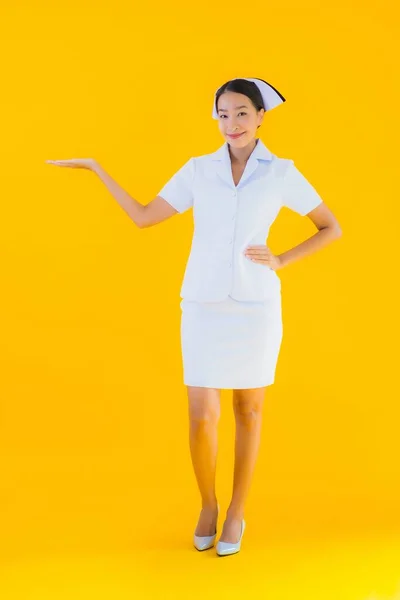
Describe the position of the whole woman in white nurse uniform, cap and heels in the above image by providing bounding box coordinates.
[47,78,341,556]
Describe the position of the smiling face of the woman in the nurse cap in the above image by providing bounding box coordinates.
[217,92,265,148]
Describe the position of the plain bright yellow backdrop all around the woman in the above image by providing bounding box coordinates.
[0,0,400,600]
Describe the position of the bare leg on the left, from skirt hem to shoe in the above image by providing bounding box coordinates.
[188,386,221,536]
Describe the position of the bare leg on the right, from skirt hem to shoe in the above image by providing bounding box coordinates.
[220,387,265,543]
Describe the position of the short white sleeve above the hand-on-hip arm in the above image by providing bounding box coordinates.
[282,159,322,217]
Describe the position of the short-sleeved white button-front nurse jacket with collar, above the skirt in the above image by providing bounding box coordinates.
[158,139,322,302]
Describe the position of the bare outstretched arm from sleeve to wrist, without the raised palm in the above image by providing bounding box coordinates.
[91,163,178,229]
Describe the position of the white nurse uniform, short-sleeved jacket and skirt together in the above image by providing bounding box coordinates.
[158,139,322,389]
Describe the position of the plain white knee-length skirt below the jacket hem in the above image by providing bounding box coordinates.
[180,291,283,390]
